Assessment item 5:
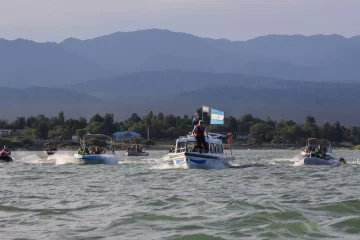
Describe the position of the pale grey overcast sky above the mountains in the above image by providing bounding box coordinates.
[0,0,360,42]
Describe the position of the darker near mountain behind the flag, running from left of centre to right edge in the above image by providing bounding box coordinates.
[66,71,360,124]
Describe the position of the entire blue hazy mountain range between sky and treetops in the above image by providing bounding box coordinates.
[0,29,360,124]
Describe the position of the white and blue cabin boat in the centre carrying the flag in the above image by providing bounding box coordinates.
[163,135,235,169]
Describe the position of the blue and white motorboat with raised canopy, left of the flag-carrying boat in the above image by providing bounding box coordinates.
[74,134,118,165]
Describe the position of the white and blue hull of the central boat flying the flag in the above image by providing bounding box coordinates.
[171,153,235,169]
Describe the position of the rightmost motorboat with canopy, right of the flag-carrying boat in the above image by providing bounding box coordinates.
[301,138,346,165]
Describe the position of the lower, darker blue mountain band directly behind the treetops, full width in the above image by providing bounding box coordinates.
[0,70,360,125]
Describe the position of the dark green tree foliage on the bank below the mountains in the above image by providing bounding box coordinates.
[0,109,360,145]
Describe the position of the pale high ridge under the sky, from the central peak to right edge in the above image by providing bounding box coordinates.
[60,29,360,82]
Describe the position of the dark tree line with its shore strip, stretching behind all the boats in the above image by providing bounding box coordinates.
[0,109,360,150]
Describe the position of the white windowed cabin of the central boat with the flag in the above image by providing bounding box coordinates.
[174,136,224,154]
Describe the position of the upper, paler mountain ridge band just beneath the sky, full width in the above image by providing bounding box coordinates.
[0,29,360,87]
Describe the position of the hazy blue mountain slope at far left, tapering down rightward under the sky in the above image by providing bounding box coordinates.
[0,39,106,87]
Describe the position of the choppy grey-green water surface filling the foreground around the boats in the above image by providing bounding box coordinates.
[0,150,360,240]
